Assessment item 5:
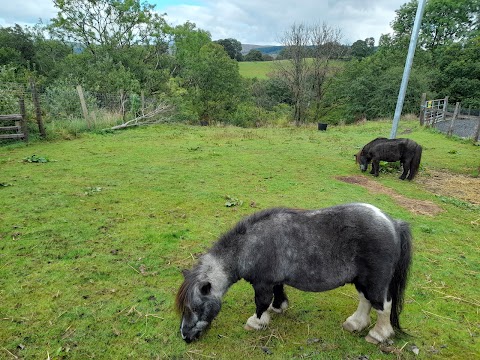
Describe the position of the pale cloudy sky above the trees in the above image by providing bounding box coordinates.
[0,0,407,45]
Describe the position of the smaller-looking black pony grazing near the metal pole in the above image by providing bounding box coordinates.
[355,138,422,180]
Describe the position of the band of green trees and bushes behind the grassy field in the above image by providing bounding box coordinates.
[0,0,480,126]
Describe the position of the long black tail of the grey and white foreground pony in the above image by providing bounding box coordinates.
[389,221,412,332]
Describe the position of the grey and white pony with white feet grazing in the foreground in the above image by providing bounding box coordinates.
[176,203,412,343]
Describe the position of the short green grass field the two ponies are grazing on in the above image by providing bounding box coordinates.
[0,121,480,359]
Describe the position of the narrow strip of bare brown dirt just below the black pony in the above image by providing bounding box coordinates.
[336,175,443,216]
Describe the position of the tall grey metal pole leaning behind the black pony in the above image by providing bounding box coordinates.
[390,0,427,139]
